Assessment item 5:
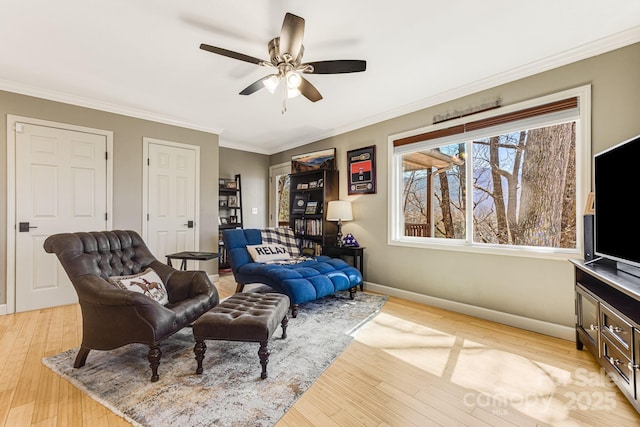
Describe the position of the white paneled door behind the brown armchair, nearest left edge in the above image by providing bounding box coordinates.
[15,123,107,311]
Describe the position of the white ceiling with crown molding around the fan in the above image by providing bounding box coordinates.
[0,0,640,154]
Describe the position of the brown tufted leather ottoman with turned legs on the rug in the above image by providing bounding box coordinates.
[193,292,289,379]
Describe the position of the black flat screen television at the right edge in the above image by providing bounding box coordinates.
[594,135,640,274]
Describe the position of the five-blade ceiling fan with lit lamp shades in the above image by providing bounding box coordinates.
[200,13,367,113]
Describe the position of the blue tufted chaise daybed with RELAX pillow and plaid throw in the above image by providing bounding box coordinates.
[222,228,362,317]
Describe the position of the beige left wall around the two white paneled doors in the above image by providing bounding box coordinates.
[0,91,218,303]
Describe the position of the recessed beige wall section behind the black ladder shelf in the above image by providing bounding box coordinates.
[220,147,269,228]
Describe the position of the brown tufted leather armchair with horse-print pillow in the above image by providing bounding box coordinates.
[44,230,219,381]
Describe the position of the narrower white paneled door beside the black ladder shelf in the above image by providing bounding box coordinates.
[145,138,199,268]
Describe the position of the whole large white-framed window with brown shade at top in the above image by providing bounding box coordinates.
[389,87,590,254]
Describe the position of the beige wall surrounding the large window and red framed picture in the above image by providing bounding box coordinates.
[271,44,640,326]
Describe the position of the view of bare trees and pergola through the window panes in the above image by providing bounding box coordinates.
[402,122,576,248]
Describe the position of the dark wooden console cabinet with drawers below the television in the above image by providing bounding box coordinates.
[571,260,640,412]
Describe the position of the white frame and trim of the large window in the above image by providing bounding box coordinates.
[387,85,592,260]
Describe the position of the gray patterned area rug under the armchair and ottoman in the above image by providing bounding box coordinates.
[43,292,387,426]
